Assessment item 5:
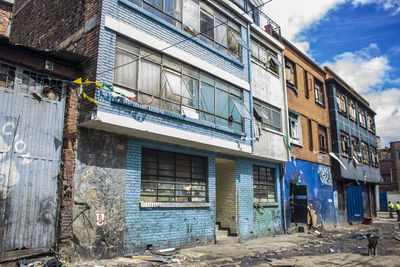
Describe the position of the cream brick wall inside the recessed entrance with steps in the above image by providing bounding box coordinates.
[215,161,237,233]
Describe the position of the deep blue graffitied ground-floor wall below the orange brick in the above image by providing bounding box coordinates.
[285,159,337,227]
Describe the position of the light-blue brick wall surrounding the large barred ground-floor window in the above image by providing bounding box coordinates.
[125,138,215,252]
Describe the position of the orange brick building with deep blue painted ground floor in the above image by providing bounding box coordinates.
[283,36,336,229]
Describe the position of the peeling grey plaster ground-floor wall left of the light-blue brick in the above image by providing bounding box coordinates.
[73,128,127,258]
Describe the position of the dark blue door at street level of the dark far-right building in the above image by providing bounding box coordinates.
[346,186,364,222]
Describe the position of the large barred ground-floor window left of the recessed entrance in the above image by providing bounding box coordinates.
[140,148,207,202]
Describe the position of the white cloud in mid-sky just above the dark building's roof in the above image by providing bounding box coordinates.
[323,44,390,93]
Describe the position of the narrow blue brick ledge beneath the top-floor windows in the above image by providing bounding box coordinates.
[118,0,244,68]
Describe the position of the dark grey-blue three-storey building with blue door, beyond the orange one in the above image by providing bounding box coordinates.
[324,67,380,224]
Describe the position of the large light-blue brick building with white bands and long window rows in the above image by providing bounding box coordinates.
[11,0,288,257]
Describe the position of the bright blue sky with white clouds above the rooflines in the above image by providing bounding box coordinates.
[264,0,400,146]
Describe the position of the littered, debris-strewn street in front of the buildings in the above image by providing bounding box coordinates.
[61,213,400,267]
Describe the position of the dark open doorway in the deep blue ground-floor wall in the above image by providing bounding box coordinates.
[290,183,307,223]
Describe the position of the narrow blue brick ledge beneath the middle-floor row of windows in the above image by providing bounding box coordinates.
[108,91,244,137]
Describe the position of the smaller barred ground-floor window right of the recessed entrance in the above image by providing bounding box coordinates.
[253,166,276,203]
